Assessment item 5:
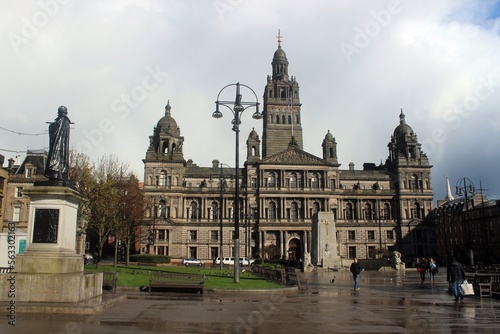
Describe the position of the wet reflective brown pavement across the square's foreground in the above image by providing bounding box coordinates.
[0,270,500,334]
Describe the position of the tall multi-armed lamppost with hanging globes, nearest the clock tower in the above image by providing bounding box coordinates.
[212,82,262,283]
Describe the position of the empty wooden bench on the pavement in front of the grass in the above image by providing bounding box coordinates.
[149,272,205,294]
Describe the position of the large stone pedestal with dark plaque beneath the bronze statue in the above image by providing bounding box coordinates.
[0,185,102,302]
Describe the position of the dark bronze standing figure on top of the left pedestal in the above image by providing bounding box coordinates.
[44,106,71,181]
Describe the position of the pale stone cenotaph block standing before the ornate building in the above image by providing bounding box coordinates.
[311,212,340,268]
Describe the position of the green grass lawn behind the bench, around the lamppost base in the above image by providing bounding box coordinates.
[85,264,283,289]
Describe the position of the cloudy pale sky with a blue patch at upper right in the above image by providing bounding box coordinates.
[0,0,500,200]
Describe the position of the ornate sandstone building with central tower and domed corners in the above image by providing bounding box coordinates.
[141,39,436,260]
